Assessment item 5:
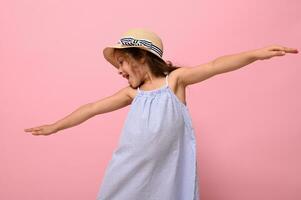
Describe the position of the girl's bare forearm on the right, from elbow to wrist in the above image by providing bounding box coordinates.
[212,50,257,74]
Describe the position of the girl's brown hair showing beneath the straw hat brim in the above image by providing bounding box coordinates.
[114,47,180,77]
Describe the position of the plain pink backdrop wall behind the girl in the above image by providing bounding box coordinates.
[0,0,301,200]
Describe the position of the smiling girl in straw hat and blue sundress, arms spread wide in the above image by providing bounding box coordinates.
[25,28,298,200]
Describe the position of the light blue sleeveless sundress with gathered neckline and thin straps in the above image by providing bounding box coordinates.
[97,74,199,200]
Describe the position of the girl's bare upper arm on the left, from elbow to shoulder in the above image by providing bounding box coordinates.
[91,86,132,115]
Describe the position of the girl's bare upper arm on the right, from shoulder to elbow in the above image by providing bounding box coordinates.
[178,62,215,86]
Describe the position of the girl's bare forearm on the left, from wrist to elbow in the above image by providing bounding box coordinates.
[54,104,93,131]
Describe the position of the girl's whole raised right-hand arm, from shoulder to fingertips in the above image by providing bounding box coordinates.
[177,45,298,87]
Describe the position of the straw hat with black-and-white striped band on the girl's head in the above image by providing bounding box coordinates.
[103,28,165,69]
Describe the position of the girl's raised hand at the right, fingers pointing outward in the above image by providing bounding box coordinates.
[254,45,298,60]
